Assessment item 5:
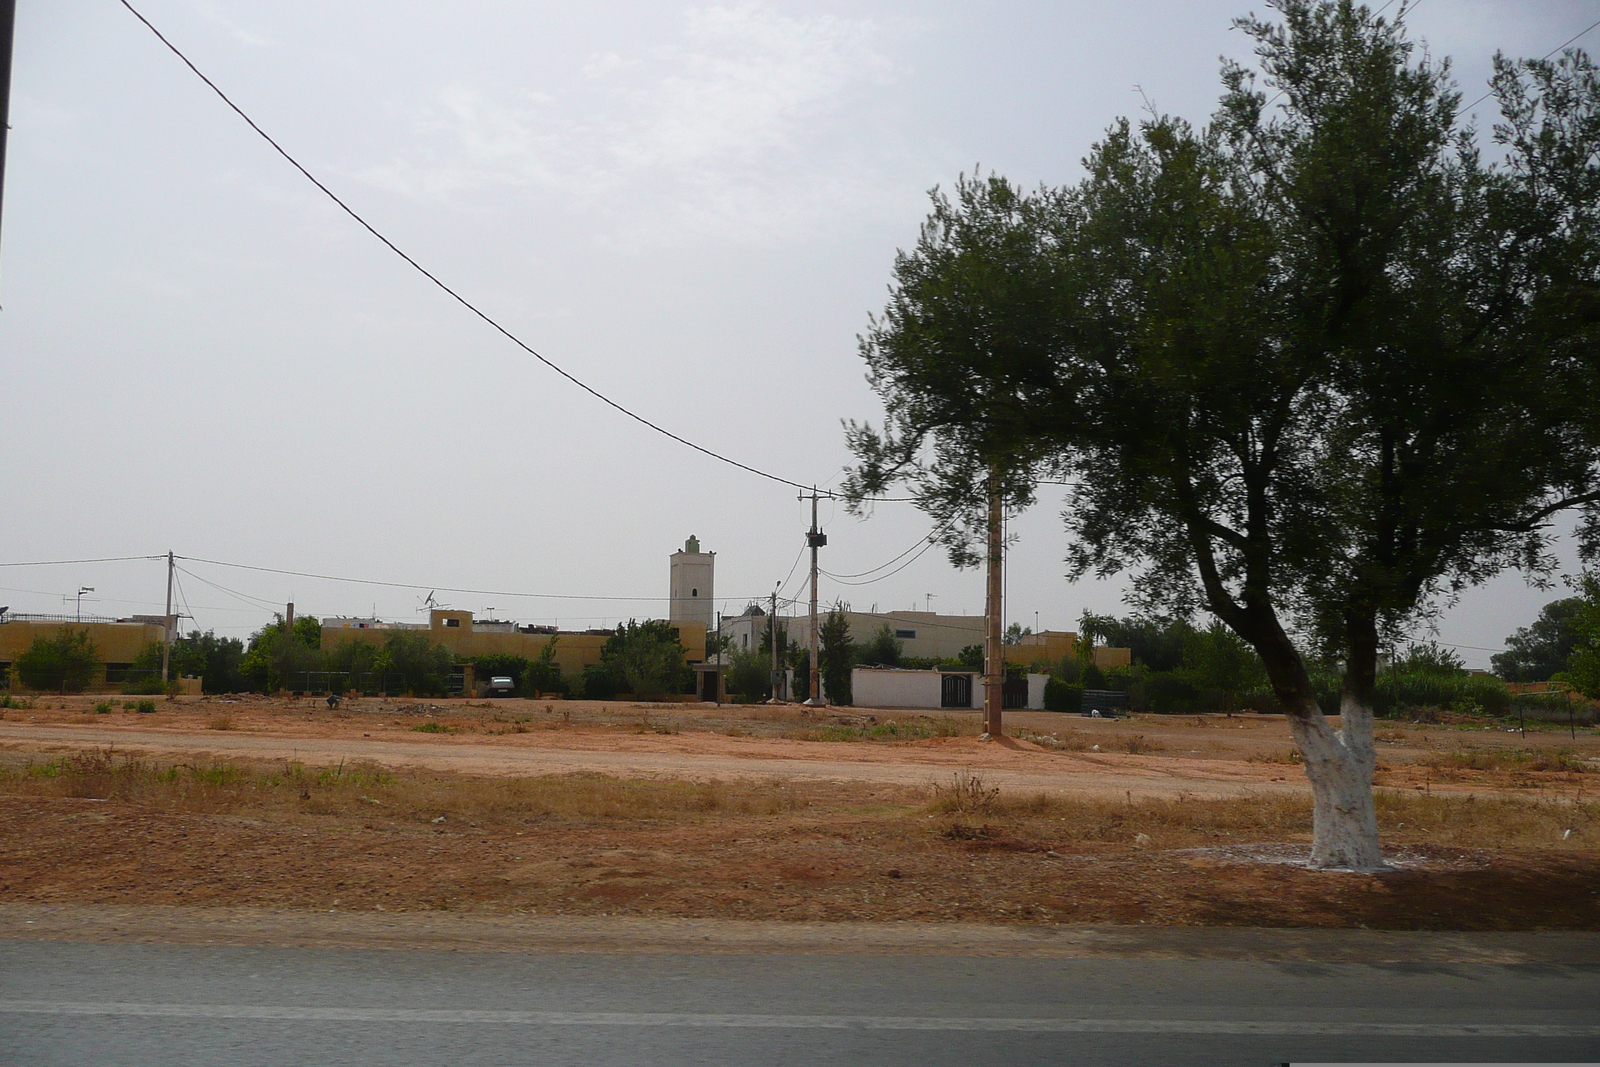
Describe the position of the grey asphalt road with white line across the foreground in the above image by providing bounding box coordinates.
[0,941,1600,1067]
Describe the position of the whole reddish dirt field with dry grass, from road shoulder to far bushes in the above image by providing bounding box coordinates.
[0,697,1600,929]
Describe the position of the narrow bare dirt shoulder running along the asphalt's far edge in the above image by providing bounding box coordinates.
[0,904,1600,965]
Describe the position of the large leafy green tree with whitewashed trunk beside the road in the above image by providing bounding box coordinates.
[851,0,1600,867]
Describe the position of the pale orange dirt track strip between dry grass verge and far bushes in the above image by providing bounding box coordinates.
[0,696,1600,797]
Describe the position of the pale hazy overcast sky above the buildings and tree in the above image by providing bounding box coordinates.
[0,0,1600,665]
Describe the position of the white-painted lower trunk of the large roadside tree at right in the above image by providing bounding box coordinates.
[1290,694,1387,870]
